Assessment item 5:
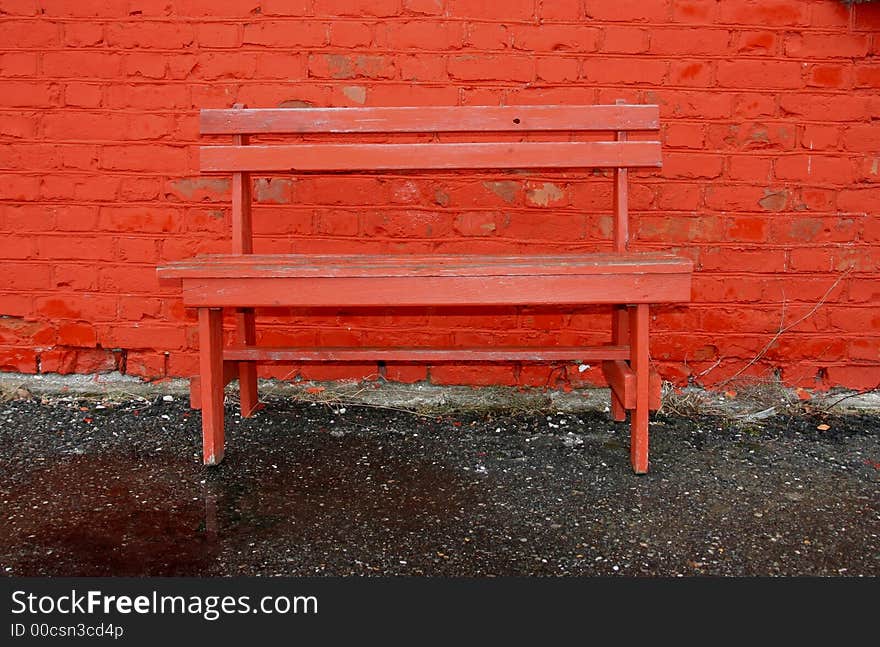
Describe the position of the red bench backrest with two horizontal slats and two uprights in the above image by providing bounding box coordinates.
[200,102,660,254]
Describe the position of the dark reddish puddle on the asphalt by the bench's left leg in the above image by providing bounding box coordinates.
[0,434,474,576]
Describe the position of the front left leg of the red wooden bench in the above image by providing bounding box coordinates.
[199,308,224,465]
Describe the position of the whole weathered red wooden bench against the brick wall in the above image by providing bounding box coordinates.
[158,103,693,473]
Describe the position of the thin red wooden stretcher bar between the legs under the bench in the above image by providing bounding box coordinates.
[223,344,629,363]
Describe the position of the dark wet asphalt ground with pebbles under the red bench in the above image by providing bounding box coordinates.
[0,396,880,577]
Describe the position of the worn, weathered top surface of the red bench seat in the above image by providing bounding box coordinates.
[158,253,693,279]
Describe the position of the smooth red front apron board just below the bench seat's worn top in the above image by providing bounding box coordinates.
[175,273,691,308]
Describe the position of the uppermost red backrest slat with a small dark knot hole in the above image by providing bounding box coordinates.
[201,105,660,135]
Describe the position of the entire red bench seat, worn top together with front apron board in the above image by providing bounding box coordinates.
[159,253,693,307]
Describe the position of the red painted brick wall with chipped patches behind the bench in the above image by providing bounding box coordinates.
[0,0,880,388]
